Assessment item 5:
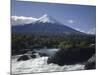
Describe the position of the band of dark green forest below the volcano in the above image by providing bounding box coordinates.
[11,34,95,52]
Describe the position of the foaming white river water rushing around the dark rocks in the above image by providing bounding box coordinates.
[11,49,84,74]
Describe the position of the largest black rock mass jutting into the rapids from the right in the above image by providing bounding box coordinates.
[47,47,95,66]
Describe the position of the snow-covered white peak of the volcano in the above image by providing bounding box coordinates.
[38,14,57,23]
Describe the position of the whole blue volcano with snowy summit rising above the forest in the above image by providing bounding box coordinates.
[12,15,84,36]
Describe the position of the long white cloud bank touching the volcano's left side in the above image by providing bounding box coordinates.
[11,16,37,25]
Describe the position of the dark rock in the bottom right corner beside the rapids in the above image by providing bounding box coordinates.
[85,55,96,70]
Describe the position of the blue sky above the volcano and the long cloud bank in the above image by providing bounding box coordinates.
[11,0,96,33]
